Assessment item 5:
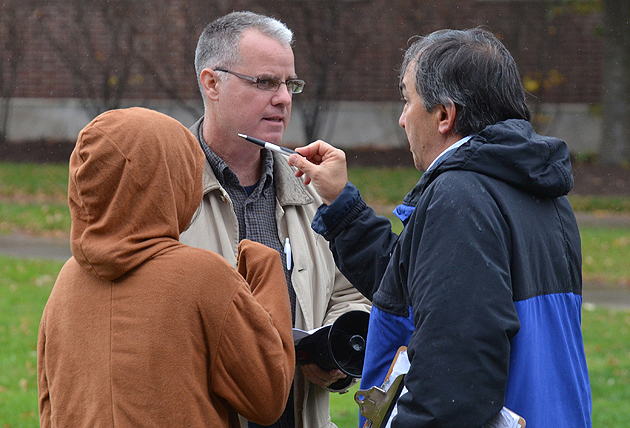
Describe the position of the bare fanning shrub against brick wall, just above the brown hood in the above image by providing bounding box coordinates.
[41,0,149,116]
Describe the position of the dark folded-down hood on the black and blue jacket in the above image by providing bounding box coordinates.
[404,119,573,206]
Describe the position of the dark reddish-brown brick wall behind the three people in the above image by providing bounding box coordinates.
[3,0,602,104]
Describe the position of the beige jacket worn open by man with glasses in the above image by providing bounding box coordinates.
[180,118,370,428]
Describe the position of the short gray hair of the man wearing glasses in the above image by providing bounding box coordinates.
[195,12,293,101]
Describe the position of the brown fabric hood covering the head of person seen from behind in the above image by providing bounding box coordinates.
[68,108,205,280]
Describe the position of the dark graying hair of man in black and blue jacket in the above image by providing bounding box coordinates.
[400,28,530,136]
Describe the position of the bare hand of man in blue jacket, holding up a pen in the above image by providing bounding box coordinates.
[289,140,348,205]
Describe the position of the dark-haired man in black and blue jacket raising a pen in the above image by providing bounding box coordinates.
[289,29,591,428]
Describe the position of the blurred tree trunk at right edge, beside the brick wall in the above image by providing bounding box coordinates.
[599,0,630,165]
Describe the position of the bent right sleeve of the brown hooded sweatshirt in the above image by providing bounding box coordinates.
[213,240,295,425]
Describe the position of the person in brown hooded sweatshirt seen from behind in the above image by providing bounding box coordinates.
[37,108,295,428]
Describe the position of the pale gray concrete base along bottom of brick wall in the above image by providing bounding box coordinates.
[3,98,602,153]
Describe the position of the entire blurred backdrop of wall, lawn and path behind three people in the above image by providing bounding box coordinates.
[0,0,630,428]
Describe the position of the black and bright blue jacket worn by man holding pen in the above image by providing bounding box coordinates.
[313,120,591,428]
